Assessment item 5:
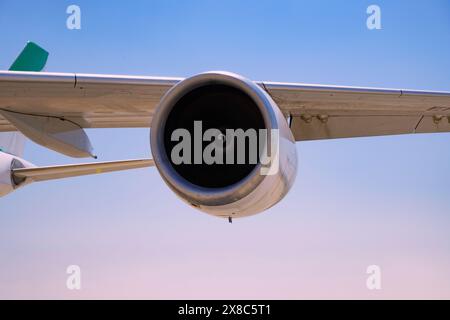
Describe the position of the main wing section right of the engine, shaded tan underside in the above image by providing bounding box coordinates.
[264,83,450,141]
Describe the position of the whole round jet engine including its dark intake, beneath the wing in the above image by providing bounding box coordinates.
[150,72,297,217]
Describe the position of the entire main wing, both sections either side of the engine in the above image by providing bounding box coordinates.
[0,71,450,141]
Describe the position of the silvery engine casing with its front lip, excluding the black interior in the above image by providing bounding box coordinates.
[150,72,297,217]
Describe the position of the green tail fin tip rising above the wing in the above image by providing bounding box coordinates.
[9,42,48,72]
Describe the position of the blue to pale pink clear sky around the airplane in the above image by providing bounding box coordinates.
[0,0,450,299]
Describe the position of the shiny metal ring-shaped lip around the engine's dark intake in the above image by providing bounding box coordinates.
[150,71,278,206]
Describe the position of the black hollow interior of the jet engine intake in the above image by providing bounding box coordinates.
[163,85,265,188]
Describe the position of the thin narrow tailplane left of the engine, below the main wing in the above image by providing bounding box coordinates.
[12,159,154,184]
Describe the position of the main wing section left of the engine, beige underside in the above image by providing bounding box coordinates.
[0,71,182,131]
